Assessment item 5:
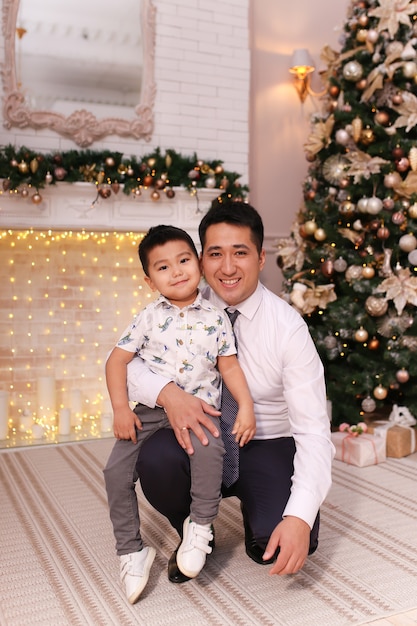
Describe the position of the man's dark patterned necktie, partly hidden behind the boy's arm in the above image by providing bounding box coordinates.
[220,309,239,487]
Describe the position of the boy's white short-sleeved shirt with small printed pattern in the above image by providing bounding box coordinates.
[117,293,236,408]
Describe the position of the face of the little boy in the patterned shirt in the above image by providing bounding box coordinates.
[145,240,201,308]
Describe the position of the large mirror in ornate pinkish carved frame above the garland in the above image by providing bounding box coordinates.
[2,0,156,148]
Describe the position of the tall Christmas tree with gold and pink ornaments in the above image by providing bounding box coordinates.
[277,0,417,425]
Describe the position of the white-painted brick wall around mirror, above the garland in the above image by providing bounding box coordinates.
[0,0,250,183]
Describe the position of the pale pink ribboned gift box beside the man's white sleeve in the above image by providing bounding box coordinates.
[331,432,387,467]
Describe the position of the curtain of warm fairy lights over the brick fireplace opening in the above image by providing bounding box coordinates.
[0,229,150,446]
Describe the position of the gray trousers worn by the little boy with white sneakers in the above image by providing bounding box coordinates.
[104,404,224,556]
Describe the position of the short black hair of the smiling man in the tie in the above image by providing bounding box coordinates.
[198,200,264,254]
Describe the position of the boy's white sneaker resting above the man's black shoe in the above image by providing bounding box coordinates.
[177,517,213,578]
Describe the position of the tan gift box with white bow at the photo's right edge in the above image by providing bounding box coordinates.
[367,404,416,459]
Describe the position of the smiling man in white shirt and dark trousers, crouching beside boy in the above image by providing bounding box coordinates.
[128,202,334,582]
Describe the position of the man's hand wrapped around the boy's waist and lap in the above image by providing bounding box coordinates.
[157,382,220,454]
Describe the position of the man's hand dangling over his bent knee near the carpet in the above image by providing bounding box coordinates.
[264,516,310,576]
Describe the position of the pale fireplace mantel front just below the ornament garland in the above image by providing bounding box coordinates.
[0,182,220,243]
